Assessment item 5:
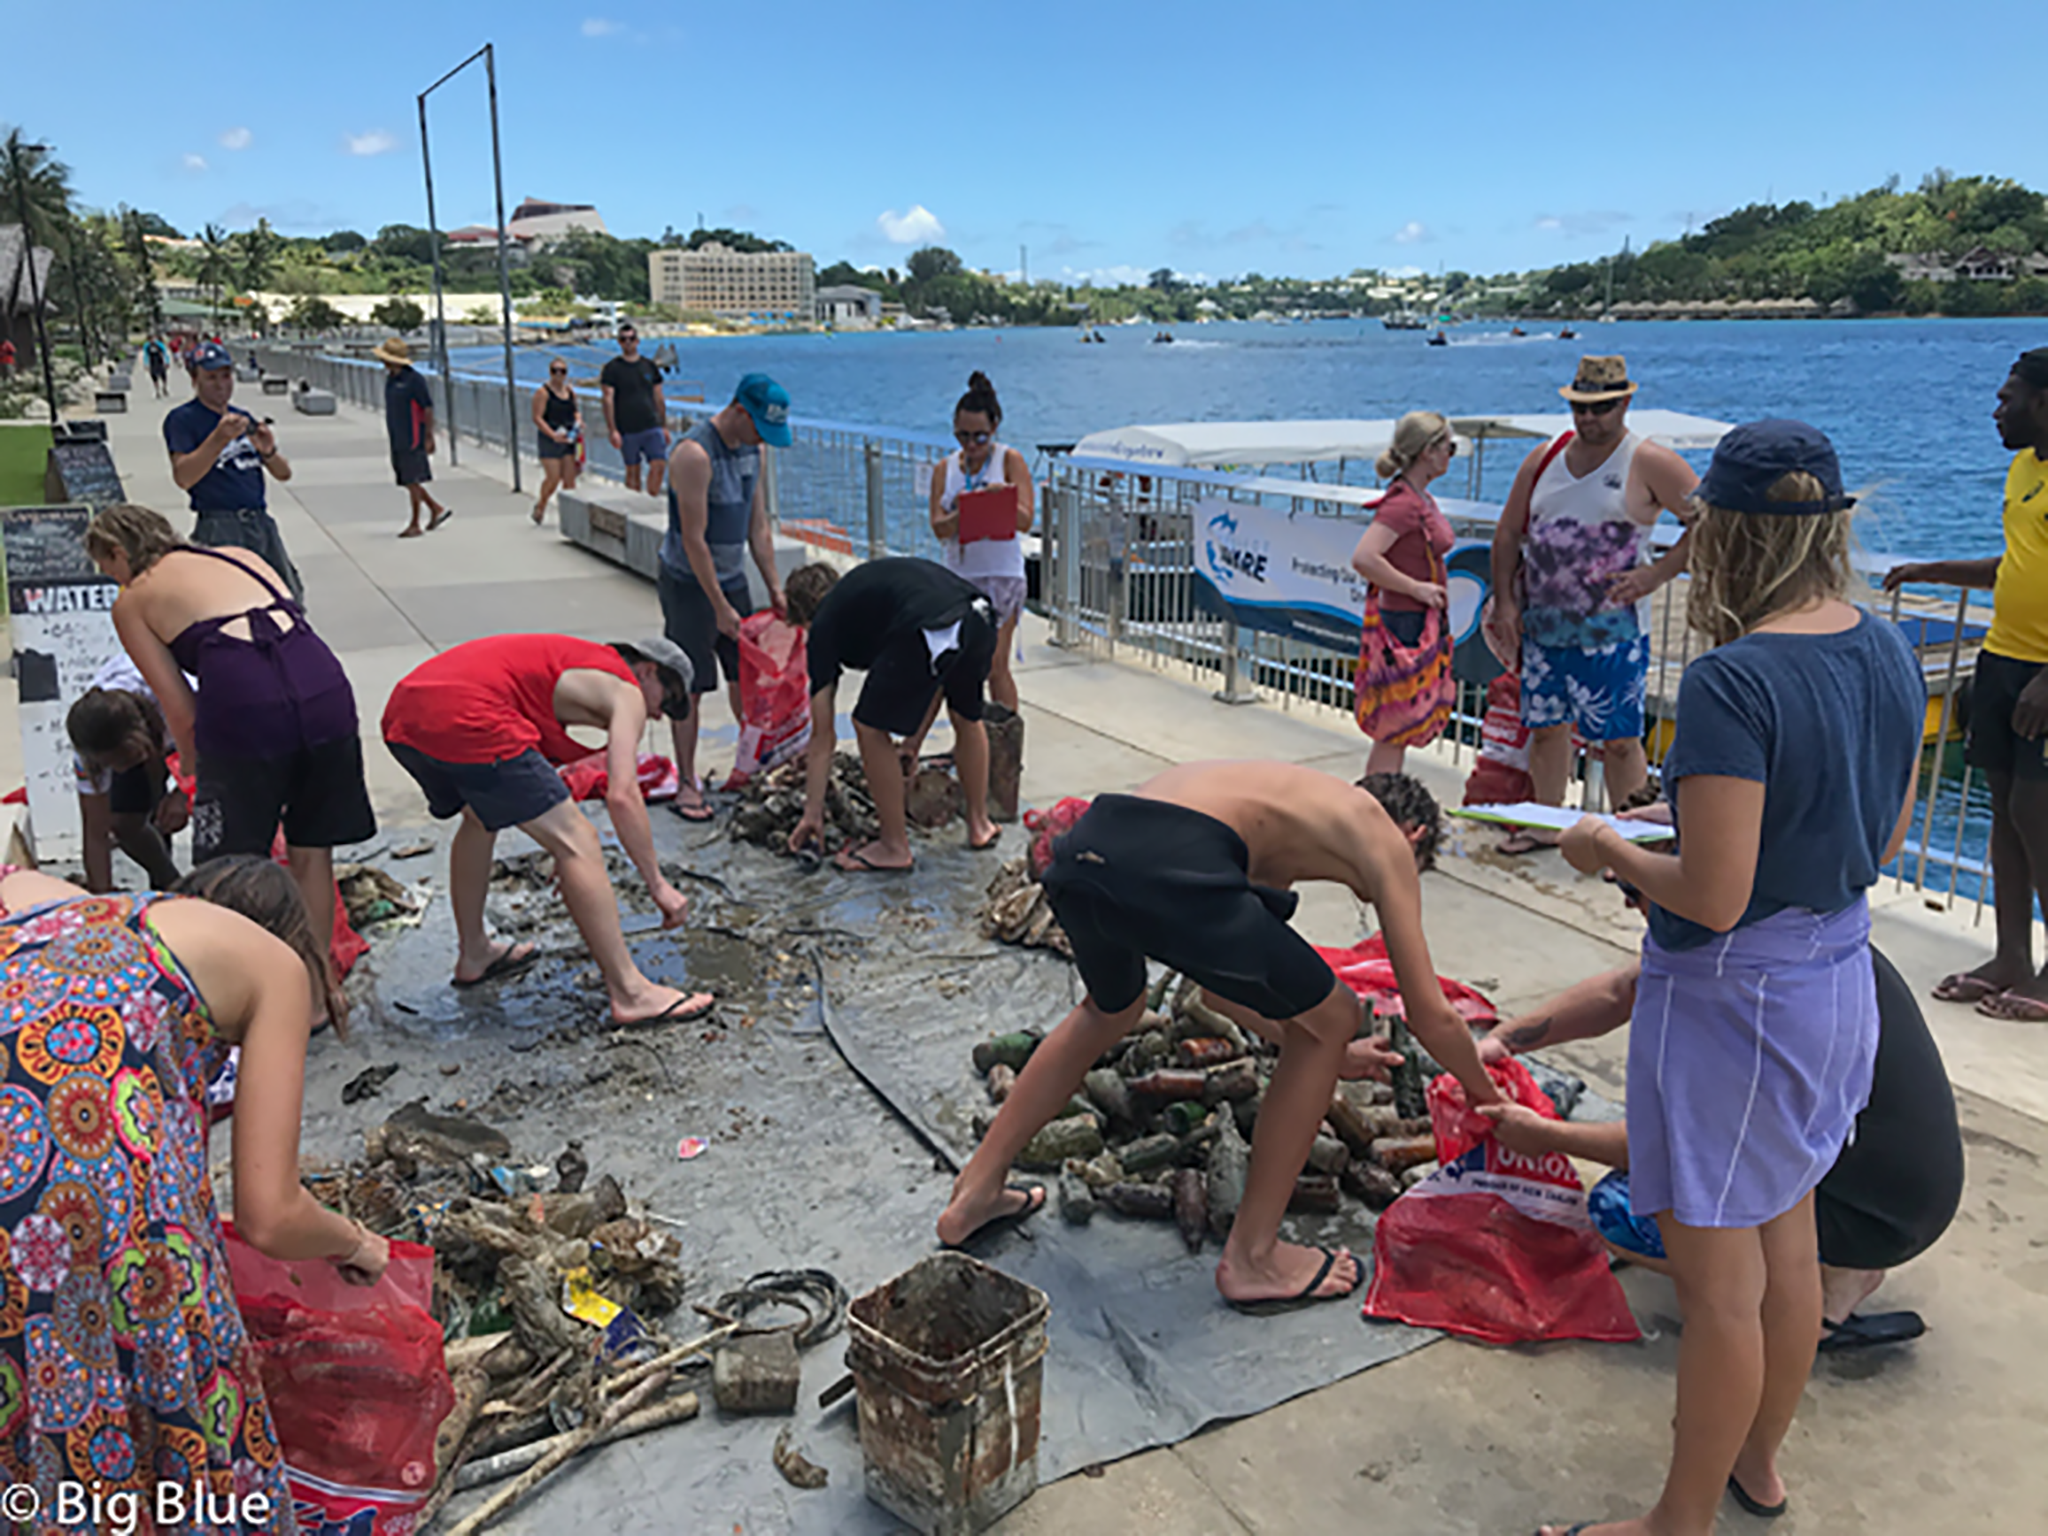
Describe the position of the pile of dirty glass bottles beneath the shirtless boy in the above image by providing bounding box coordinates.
[973,974,1438,1253]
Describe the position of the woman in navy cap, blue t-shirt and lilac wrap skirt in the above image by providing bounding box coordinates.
[1563,420,1927,1536]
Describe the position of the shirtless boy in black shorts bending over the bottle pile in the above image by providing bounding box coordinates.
[938,762,1499,1311]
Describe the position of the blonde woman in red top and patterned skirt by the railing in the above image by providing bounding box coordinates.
[1352,412,1458,776]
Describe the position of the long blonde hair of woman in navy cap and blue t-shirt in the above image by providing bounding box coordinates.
[1686,471,1855,645]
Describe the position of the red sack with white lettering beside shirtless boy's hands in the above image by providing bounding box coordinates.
[1364,1061,1642,1343]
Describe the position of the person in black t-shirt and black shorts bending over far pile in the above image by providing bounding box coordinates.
[782,557,999,870]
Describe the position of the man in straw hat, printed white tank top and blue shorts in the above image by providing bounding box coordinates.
[1491,356,1700,854]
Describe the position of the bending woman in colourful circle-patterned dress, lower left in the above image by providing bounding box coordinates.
[0,858,389,1532]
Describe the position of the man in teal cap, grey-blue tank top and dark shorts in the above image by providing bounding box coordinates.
[659,374,791,821]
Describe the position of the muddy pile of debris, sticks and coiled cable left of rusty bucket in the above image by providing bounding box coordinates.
[301,1100,846,1532]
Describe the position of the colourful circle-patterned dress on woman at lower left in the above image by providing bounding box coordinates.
[0,897,293,1536]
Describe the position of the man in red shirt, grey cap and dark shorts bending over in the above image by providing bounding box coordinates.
[383,635,713,1024]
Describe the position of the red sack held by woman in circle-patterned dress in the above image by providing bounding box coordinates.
[225,1225,455,1536]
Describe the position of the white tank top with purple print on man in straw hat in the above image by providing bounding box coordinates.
[1522,432,1649,649]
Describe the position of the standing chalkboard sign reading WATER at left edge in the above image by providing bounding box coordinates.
[0,506,121,864]
